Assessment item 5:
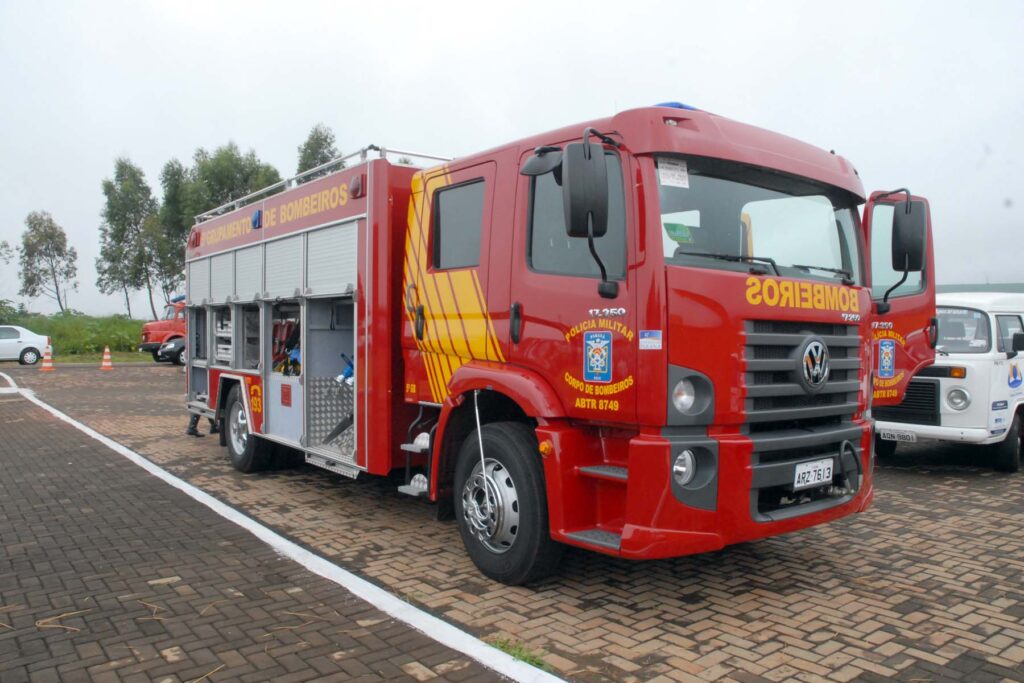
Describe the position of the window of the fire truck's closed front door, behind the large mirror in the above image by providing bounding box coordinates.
[526,152,626,280]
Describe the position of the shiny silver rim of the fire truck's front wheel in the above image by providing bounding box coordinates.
[462,458,519,554]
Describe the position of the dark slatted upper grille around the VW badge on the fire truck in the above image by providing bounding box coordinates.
[744,321,860,428]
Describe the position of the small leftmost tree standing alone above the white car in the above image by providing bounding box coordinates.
[16,211,78,313]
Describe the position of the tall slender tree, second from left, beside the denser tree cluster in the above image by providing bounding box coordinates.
[97,157,158,317]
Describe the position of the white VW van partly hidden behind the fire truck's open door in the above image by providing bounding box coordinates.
[872,292,1024,472]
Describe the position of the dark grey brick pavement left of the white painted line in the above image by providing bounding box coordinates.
[0,382,496,683]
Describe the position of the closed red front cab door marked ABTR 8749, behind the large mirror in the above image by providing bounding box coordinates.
[502,148,638,422]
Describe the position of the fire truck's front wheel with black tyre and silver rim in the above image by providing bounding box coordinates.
[455,422,562,586]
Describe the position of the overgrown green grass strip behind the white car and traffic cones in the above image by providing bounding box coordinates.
[0,313,145,356]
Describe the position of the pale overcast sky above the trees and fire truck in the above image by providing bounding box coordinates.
[0,0,1024,315]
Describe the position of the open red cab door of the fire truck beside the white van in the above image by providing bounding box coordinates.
[864,190,937,405]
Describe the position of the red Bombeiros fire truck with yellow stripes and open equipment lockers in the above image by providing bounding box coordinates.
[187,102,935,584]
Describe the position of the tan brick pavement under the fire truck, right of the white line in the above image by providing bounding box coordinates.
[3,367,1024,682]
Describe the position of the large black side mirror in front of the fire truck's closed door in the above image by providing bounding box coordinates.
[562,141,608,238]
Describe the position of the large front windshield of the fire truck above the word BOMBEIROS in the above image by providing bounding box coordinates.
[655,155,862,284]
